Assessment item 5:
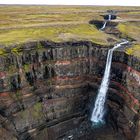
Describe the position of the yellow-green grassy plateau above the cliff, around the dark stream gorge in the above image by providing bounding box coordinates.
[0,6,140,55]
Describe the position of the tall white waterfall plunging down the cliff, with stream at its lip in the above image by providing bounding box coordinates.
[91,40,128,124]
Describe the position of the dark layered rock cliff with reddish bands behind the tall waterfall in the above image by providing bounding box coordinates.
[0,41,140,140]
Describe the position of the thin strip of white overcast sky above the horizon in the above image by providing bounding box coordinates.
[0,0,140,6]
